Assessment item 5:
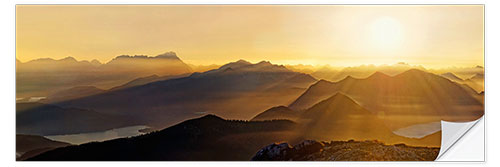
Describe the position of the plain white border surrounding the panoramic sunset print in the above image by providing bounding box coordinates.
[0,0,500,167]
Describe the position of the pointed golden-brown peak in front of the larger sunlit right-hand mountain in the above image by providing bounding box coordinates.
[252,93,441,147]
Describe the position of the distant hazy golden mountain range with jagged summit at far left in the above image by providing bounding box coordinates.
[16,52,192,97]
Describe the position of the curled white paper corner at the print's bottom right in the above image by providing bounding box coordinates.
[436,116,484,161]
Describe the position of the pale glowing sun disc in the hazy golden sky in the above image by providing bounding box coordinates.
[368,17,403,51]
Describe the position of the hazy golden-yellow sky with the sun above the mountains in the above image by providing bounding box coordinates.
[16,5,484,67]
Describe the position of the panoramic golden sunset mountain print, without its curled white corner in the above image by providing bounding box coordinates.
[16,5,485,161]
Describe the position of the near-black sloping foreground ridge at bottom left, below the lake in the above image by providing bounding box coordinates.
[28,115,295,161]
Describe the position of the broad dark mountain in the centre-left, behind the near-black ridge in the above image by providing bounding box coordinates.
[47,60,316,128]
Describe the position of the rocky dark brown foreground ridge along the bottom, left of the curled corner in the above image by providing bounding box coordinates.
[252,140,439,161]
